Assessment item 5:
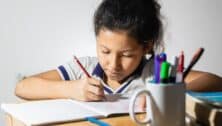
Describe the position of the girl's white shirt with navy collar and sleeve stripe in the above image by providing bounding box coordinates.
[57,57,153,94]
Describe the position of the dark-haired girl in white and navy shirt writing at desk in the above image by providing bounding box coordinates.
[15,0,222,101]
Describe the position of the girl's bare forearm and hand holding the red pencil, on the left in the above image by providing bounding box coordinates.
[15,70,104,101]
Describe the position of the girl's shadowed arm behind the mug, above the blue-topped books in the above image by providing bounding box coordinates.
[185,71,222,91]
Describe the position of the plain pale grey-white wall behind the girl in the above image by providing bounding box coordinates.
[0,0,222,125]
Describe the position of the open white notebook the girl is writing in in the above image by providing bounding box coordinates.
[1,95,142,125]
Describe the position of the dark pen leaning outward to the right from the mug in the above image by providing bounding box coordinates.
[183,48,204,80]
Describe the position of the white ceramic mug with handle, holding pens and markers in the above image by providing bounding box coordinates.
[129,83,185,126]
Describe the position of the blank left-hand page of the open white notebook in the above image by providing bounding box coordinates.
[1,99,101,125]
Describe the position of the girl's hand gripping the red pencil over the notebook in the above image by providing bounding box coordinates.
[71,77,105,101]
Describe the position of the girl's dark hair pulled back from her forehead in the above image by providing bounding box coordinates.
[94,0,163,50]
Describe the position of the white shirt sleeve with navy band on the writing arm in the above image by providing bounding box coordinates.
[56,57,98,80]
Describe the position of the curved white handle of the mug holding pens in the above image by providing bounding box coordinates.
[129,89,151,125]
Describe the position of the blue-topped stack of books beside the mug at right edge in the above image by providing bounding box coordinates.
[186,91,222,126]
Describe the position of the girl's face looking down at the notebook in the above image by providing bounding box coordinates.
[96,29,151,82]
